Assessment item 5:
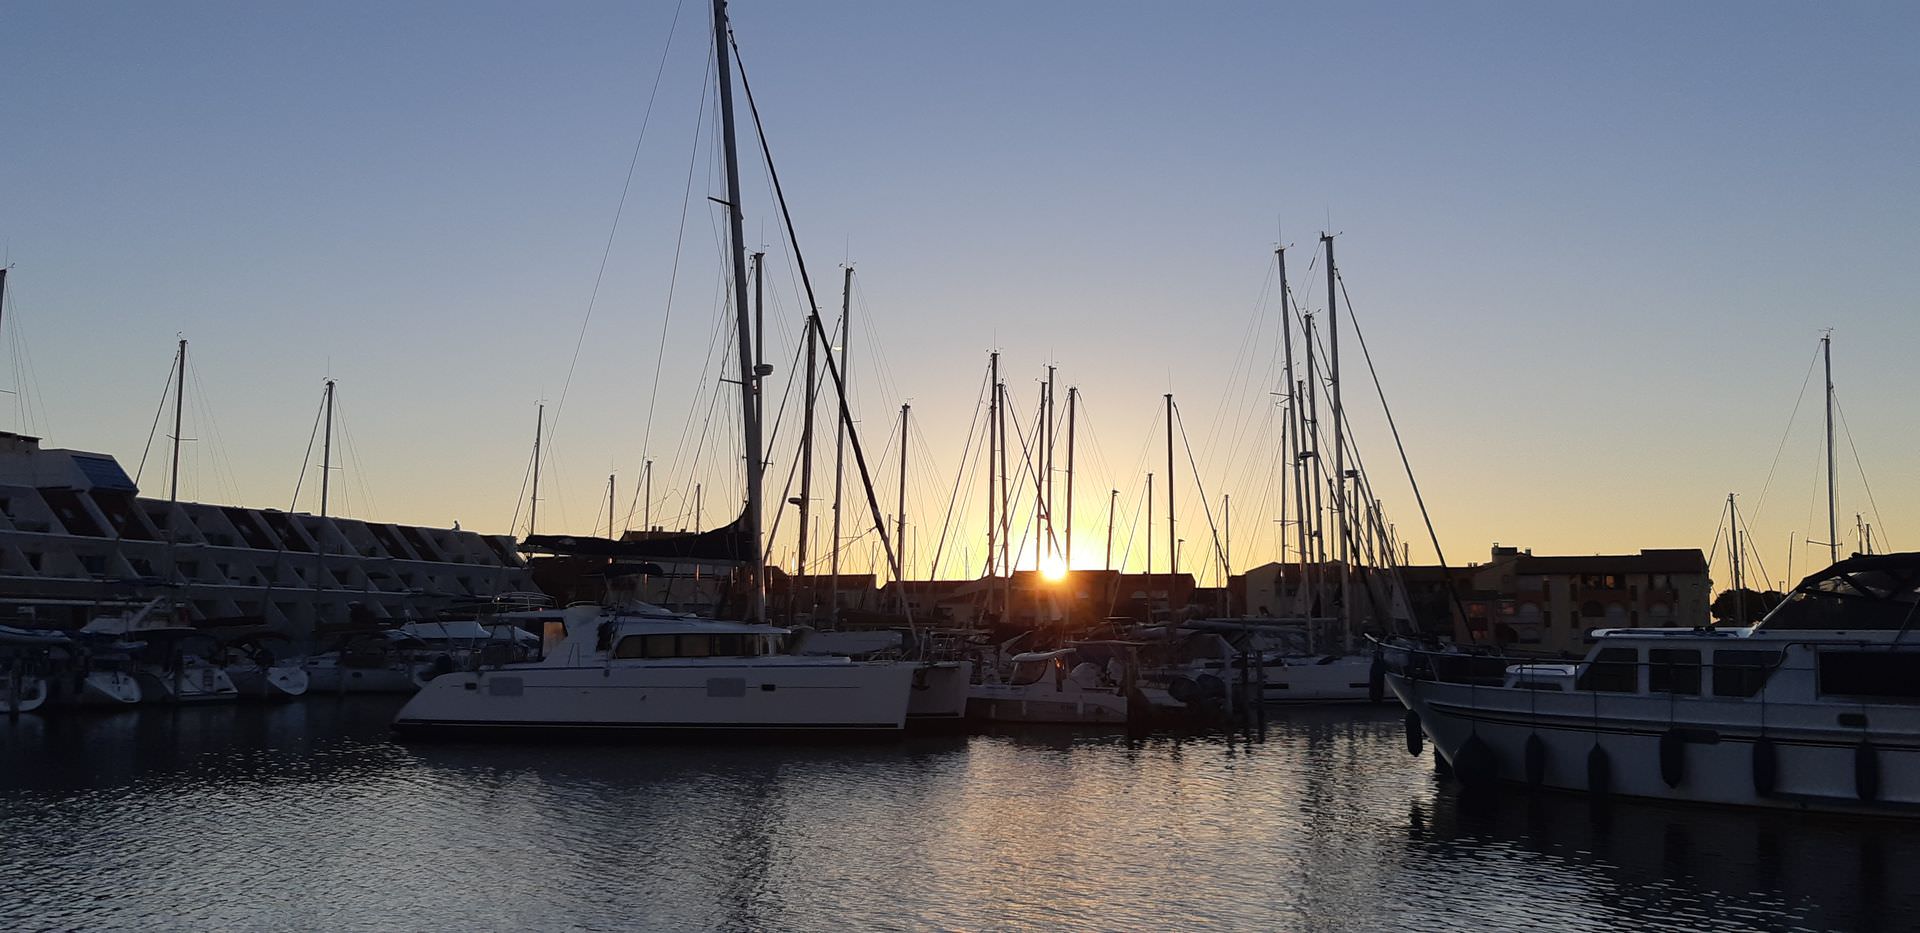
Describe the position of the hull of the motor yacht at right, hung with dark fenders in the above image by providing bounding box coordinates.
[1386,674,1920,816]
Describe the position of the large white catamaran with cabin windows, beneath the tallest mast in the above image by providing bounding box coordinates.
[394,605,916,739]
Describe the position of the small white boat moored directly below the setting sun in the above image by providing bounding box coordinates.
[968,647,1146,726]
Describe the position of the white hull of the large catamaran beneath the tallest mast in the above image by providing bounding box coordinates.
[394,662,914,741]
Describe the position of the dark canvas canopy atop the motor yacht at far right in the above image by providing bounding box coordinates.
[1755,551,1920,632]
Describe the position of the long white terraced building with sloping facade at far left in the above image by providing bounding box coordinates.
[0,432,532,637]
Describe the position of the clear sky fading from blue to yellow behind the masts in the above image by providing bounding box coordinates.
[0,0,1920,582]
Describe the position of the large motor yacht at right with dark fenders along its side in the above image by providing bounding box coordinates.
[1382,553,1920,816]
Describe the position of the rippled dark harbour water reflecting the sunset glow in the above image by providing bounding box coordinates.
[0,699,1920,931]
